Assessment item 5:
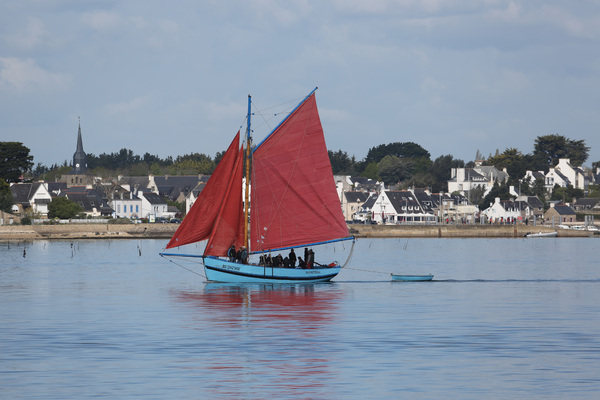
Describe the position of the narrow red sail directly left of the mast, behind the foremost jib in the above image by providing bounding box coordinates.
[204,146,244,257]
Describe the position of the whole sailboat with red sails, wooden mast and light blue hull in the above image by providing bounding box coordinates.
[160,88,354,283]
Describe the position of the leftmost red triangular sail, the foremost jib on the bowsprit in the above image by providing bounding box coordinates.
[167,132,240,249]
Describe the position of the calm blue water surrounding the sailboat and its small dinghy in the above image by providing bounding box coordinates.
[0,239,600,399]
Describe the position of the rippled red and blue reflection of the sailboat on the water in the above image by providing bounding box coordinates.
[172,283,344,398]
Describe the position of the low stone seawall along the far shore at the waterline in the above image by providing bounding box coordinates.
[0,224,598,241]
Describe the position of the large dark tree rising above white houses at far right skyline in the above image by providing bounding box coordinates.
[533,133,590,168]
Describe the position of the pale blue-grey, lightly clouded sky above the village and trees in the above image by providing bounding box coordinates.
[0,0,600,166]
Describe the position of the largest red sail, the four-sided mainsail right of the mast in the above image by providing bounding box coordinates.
[250,93,348,251]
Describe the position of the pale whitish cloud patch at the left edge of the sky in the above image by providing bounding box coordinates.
[0,57,71,91]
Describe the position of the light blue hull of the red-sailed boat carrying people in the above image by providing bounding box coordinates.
[204,257,342,283]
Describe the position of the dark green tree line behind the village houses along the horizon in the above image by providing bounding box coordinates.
[0,134,600,212]
